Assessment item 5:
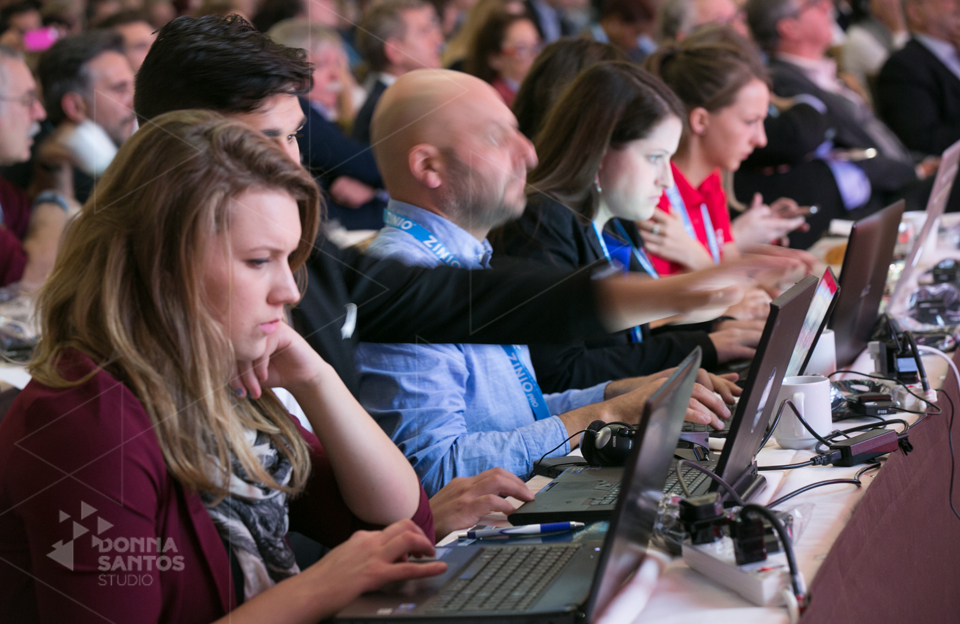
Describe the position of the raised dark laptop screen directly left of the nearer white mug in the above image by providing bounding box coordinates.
[713,275,818,489]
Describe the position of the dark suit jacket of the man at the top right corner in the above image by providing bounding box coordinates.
[877,39,960,155]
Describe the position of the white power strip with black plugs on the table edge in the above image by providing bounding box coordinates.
[683,536,790,607]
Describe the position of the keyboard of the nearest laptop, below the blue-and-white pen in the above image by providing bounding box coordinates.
[426,544,580,613]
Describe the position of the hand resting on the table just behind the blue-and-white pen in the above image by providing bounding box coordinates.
[430,468,533,540]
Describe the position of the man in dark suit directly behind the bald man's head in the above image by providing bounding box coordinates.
[353,0,443,144]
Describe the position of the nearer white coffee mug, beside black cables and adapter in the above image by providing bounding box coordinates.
[773,375,833,449]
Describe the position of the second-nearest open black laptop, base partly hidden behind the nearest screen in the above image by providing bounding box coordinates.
[510,275,818,524]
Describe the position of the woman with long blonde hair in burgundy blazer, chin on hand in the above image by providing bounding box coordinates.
[0,111,445,623]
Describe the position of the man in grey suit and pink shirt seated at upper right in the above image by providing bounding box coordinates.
[746,0,936,232]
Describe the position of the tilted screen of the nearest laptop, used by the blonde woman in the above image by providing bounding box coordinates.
[585,347,701,622]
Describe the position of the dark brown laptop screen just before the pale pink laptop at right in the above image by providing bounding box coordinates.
[830,200,905,369]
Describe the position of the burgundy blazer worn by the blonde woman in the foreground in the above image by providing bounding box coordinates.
[0,352,433,624]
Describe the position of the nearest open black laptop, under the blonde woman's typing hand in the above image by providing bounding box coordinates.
[335,347,700,624]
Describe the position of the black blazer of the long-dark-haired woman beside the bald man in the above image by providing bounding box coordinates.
[491,193,717,392]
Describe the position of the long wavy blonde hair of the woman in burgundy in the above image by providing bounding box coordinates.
[30,110,320,502]
